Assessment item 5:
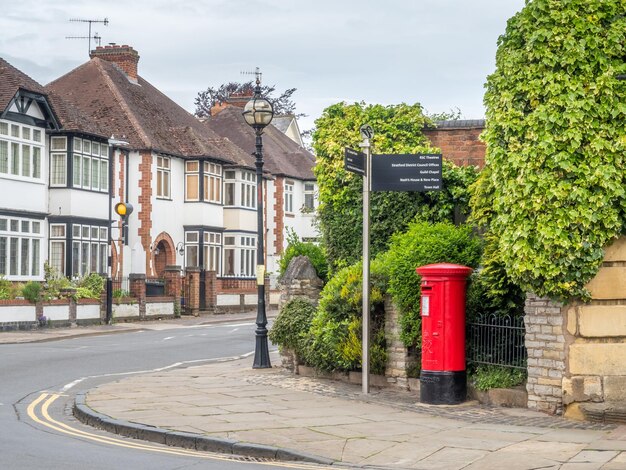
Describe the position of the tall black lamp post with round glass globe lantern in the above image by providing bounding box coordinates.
[243,75,274,369]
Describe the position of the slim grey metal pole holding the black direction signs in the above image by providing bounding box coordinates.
[359,125,374,395]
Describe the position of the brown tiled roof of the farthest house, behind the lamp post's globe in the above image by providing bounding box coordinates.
[206,106,315,180]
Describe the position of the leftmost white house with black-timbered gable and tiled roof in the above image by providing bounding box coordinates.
[0,59,114,281]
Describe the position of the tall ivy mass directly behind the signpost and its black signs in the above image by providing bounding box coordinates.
[313,103,476,271]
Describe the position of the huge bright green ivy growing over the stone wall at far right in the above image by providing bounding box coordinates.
[471,0,626,300]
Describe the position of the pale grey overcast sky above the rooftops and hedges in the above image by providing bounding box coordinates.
[0,0,524,129]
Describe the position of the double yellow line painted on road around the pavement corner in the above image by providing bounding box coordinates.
[26,393,323,469]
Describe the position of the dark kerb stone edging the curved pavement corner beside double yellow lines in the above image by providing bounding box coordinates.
[73,393,335,465]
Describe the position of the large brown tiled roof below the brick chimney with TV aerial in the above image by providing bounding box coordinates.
[46,57,251,162]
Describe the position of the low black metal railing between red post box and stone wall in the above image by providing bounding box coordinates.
[467,315,527,369]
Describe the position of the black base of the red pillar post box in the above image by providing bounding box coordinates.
[420,370,467,405]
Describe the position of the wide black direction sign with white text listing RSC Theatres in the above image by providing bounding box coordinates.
[372,153,443,192]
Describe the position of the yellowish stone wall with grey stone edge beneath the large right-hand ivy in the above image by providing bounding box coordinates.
[525,237,626,422]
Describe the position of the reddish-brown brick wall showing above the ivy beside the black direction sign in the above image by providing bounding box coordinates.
[424,120,486,168]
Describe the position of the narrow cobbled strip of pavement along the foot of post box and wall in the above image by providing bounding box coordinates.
[241,372,617,431]
